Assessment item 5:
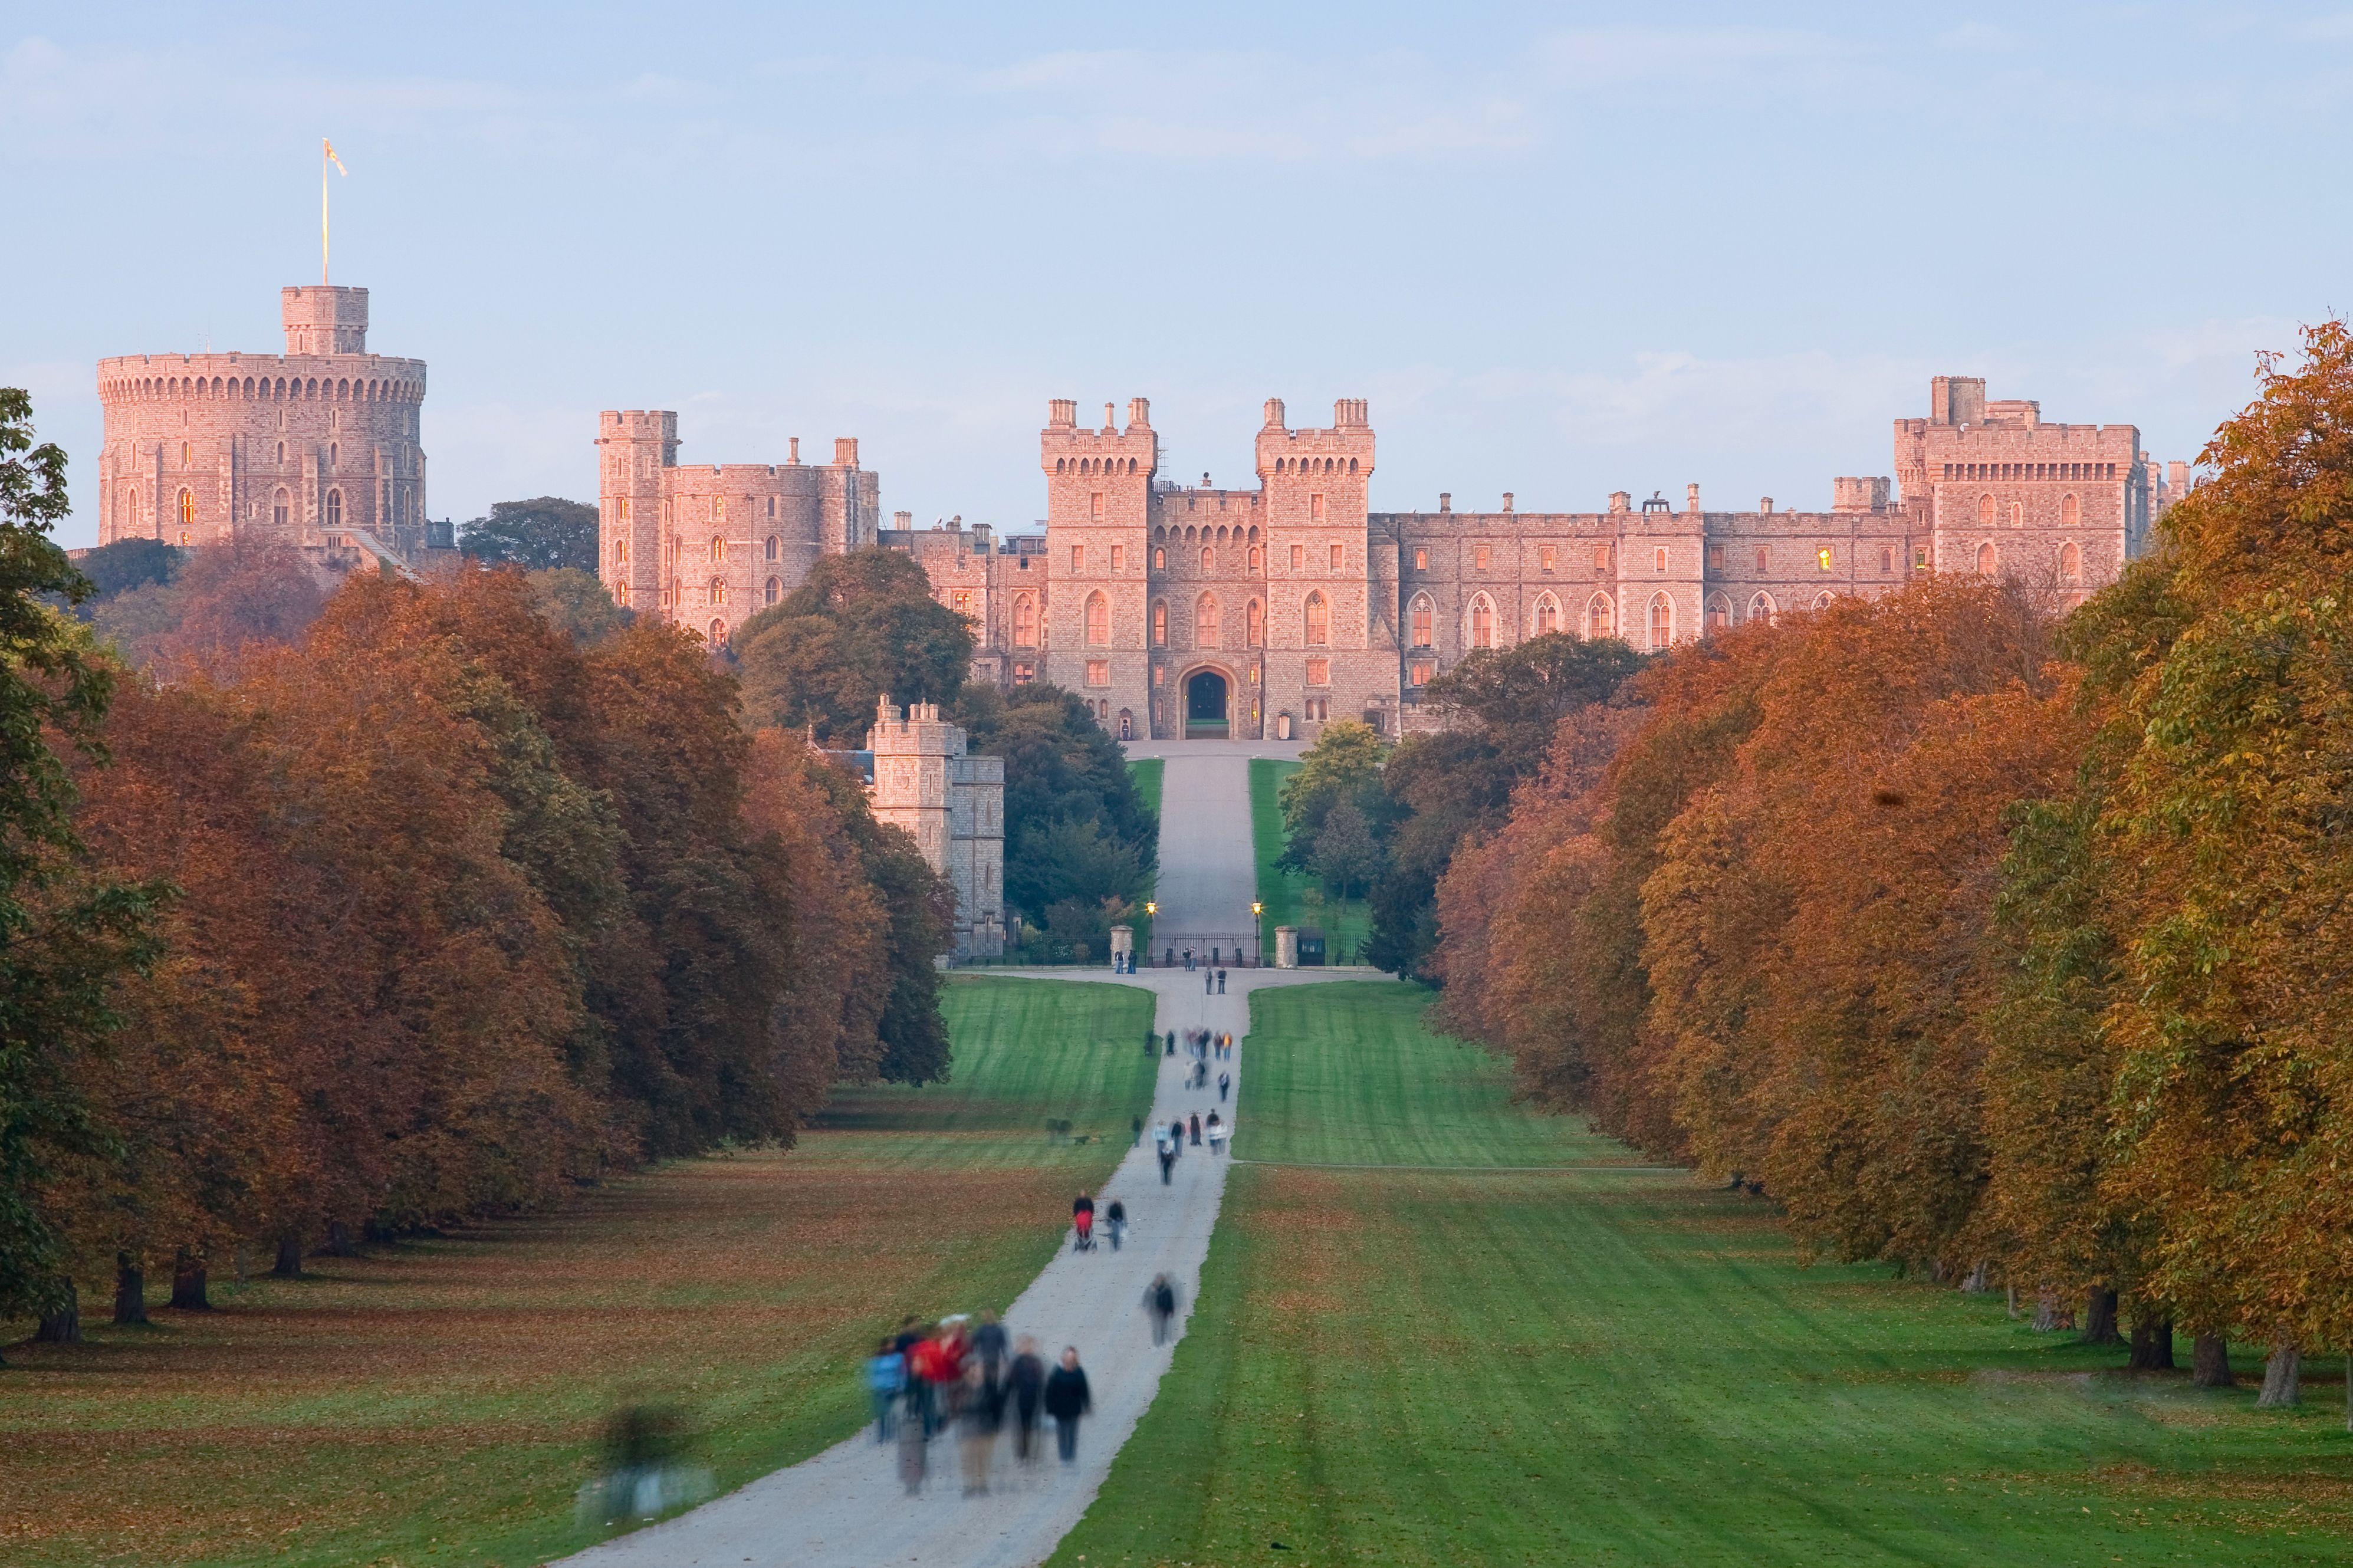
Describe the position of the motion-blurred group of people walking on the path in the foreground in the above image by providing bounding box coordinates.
[866,1311,1094,1497]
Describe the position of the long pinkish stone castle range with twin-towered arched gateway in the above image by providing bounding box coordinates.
[600,377,2188,739]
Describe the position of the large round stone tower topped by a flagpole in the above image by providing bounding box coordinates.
[99,285,449,563]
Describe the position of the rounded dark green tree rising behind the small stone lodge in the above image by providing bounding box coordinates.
[734,548,974,749]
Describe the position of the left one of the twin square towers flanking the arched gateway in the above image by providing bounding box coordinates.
[1038,398,1160,735]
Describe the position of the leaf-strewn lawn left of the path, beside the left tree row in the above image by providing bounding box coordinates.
[0,979,1153,1568]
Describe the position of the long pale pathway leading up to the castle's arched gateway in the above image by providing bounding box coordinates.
[567,747,1348,1568]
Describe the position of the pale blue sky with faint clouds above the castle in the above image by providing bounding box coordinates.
[0,0,2353,544]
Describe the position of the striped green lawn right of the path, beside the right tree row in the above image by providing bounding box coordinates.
[1052,982,2353,1568]
